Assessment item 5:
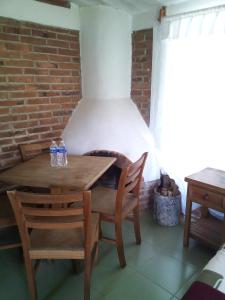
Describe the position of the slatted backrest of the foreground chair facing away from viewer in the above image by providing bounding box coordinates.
[7,191,91,251]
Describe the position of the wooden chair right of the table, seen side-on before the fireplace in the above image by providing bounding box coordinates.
[92,153,147,267]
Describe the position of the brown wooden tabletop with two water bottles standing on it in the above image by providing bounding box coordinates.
[0,154,116,191]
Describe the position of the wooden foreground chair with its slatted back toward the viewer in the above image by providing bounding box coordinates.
[8,191,99,300]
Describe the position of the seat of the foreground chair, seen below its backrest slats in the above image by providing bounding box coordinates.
[30,213,99,259]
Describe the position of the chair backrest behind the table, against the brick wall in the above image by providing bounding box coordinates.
[19,142,51,161]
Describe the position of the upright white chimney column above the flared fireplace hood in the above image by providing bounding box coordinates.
[80,6,132,99]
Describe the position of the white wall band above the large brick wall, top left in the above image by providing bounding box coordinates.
[0,0,80,29]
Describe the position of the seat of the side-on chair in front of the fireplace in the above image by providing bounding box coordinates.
[92,186,138,216]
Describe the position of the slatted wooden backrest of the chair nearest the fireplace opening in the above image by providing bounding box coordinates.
[116,152,148,213]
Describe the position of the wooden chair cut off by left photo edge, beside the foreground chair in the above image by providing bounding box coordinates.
[0,183,21,249]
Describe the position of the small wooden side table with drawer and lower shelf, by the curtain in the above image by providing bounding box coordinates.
[183,168,225,248]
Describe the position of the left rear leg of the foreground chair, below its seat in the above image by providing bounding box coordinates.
[24,254,37,300]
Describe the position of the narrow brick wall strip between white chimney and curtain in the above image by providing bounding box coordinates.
[131,29,153,124]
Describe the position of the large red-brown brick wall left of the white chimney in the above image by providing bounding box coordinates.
[0,17,81,169]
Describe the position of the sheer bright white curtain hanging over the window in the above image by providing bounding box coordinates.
[150,7,225,211]
